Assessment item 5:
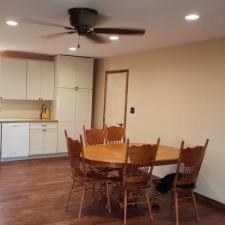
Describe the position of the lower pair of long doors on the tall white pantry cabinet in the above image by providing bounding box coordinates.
[57,88,92,152]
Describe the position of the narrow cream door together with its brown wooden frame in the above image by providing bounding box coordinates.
[103,70,129,127]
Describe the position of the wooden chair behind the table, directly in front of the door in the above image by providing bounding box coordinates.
[104,125,126,144]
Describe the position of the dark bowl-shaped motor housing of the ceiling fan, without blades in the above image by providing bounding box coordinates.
[68,8,98,35]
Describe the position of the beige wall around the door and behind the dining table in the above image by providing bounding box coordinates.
[94,39,225,203]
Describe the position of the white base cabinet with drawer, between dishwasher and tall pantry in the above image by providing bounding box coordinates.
[30,123,57,155]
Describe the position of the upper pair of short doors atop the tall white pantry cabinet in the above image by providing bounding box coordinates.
[56,55,93,89]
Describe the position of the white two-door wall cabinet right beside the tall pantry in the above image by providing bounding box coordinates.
[27,60,54,100]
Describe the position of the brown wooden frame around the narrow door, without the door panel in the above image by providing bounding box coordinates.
[103,69,129,128]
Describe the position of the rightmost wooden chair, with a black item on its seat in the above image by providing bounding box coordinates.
[171,139,209,225]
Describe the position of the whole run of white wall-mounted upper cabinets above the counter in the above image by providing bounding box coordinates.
[0,57,55,100]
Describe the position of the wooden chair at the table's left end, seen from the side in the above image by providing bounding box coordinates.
[65,131,111,218]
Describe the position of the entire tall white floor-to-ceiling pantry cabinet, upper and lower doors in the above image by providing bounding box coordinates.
[53,56,93,152]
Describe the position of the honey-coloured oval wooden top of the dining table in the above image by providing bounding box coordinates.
[84,144,179,165]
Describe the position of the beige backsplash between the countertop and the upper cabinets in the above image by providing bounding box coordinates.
[0,99,51,119]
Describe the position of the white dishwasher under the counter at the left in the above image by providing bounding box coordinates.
[1,123,29,159]
